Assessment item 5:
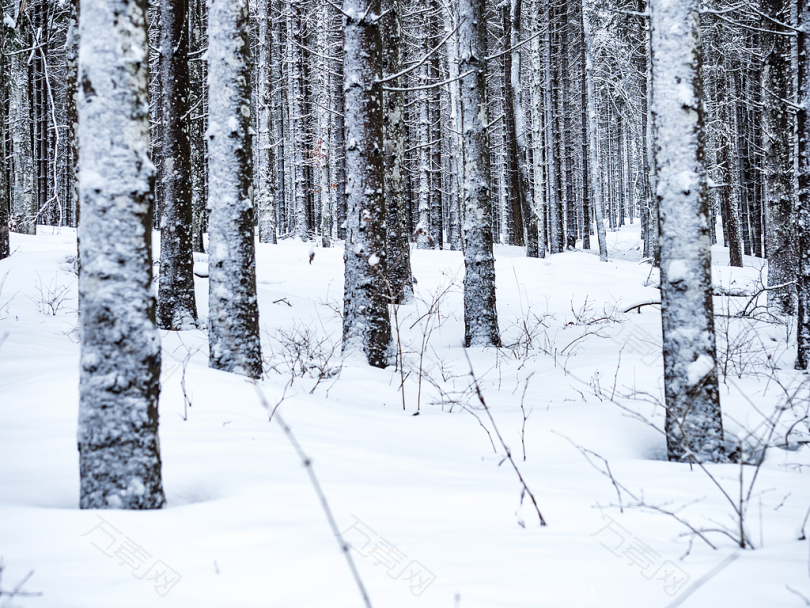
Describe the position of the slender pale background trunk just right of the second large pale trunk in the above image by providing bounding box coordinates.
[255,0,276,243]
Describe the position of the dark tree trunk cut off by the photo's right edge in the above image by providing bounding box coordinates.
[796,0,810,369]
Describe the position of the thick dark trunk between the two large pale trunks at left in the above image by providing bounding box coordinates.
[157,0,197,330]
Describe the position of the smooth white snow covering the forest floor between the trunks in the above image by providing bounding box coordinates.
[0,225,810,608]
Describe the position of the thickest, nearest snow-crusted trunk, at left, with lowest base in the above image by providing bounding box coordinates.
[78,0,165,509]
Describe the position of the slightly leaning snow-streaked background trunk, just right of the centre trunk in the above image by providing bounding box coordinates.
[509,0,539,258]
